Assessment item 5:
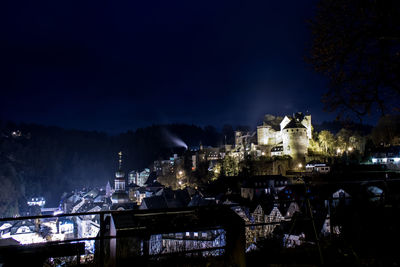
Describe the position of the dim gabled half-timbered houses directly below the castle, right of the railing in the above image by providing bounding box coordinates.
[230,176,383,251]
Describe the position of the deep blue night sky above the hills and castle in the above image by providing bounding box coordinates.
[0,0,334,133]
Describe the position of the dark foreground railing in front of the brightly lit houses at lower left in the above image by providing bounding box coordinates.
[0,206,244,266]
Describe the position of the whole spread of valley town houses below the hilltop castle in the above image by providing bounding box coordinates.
[0,163,390,262]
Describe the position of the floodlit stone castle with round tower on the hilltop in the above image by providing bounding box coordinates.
[184,112,312,176]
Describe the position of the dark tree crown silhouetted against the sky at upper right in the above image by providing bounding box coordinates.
[307,0,400,120]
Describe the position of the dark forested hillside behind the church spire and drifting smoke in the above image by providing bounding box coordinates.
[0,122,223,216]
